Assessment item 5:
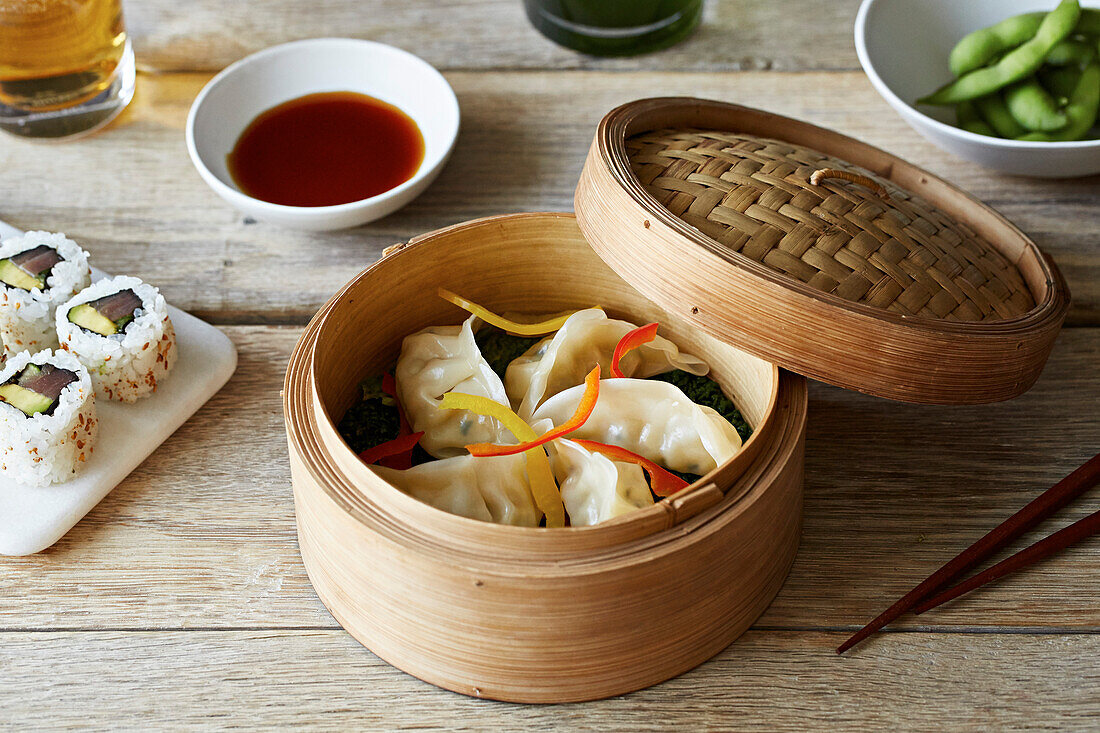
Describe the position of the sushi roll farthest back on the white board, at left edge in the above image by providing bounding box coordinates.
[0,231,91,355]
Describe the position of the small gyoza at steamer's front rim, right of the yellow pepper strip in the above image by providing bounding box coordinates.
[547,438,653,527]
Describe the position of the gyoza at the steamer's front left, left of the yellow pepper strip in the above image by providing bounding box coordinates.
[371,453,542,527]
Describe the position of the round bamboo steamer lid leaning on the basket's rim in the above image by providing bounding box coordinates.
[575,98,1069,404]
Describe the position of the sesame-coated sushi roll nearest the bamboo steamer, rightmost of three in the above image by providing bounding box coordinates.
[56,276,178,402]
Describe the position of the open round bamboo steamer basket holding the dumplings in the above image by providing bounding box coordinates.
[284,214,806,702]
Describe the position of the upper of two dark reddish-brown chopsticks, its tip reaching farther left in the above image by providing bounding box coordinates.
[836,453,1100,654]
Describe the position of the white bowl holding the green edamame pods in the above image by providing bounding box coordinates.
[856,0,1100,178]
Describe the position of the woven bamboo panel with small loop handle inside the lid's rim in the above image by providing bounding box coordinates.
[626,129,1035,321]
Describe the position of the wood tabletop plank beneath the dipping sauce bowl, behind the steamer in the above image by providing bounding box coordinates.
[0,69,1100,325]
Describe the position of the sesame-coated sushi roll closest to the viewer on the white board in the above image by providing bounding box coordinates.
[0,349,98,486]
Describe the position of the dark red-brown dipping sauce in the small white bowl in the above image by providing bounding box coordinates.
[226,91,424,206]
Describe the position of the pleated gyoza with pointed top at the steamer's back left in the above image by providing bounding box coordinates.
[394,316,515,458]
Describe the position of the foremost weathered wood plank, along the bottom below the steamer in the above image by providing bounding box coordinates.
[0,631,1100,731]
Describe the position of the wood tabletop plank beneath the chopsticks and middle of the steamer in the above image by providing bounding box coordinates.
[0,327,1100,629]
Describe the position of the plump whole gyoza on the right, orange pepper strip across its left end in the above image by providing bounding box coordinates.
[534,379,741,475]
